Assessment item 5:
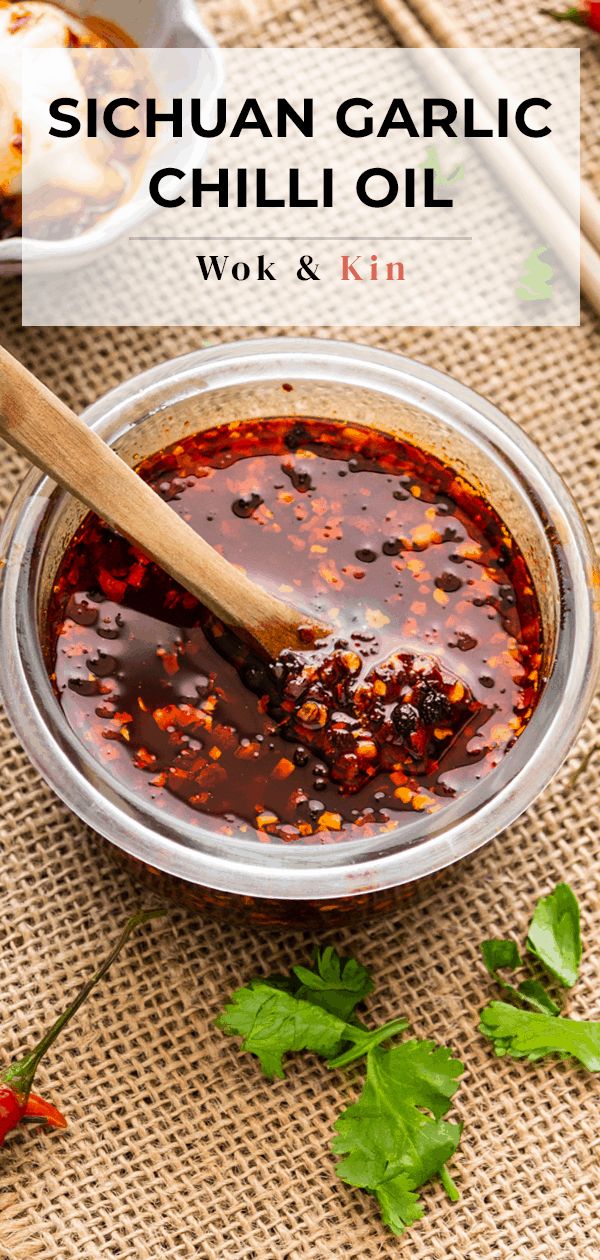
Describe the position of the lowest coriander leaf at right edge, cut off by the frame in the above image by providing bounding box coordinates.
[479,1002,600,1072]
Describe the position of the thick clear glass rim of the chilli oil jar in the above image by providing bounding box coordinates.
[0,336,599,901]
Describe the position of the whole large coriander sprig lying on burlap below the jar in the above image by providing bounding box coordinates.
[217,948,463,1235]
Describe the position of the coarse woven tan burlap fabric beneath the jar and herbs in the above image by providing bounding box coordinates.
[0,0,600,1260]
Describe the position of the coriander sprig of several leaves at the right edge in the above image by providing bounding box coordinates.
[479,883,600,1072]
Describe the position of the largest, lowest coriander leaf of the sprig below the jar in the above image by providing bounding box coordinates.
[333,1041,463,1234]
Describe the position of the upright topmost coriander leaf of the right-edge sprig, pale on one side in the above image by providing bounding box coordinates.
[527,883,581,989]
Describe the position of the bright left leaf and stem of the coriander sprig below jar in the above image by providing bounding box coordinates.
[217,980,407,1076]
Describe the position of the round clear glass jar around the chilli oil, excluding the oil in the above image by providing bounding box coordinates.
[0,336,599,922]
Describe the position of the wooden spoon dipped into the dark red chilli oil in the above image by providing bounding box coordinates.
[0,347,328,659]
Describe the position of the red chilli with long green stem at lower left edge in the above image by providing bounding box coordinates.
[0,910,165,1147]
